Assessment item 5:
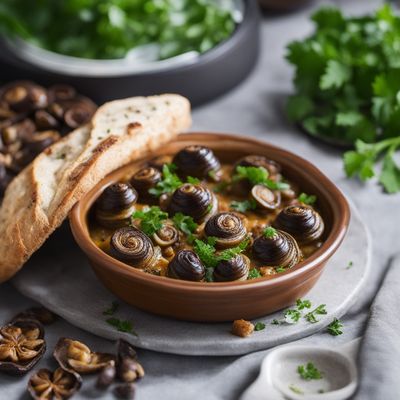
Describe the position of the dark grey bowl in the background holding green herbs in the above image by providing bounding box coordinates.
[0,0,260,105]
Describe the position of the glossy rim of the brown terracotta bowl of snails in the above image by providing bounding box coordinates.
[70,132,350,292]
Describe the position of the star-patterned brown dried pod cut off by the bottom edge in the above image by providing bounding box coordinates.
[28,368,82,400]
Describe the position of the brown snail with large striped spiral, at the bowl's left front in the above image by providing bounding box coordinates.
[110,227,161,269]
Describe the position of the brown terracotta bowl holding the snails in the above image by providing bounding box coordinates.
[70,133,350,321]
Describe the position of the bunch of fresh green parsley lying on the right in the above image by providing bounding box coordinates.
[287,5,400,193]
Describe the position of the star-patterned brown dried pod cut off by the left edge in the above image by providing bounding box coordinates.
[0,319,46,375]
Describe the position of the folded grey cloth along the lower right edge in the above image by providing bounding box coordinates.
[354,254,400,400]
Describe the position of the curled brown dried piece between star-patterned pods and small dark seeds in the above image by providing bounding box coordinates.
[53,338,115,374]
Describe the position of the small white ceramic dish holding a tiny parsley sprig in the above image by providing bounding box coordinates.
[241,339,360,400]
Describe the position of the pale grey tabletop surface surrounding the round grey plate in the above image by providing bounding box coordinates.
[0,0,400,400]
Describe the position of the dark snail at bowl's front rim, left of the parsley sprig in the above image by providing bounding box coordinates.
[167,250,205,282]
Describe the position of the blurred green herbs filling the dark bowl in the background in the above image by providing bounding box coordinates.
[0,0,235,59]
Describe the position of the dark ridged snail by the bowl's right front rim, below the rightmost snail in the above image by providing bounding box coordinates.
[252,230,301,268]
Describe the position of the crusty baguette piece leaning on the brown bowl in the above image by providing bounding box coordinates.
[0,95,191,282]
